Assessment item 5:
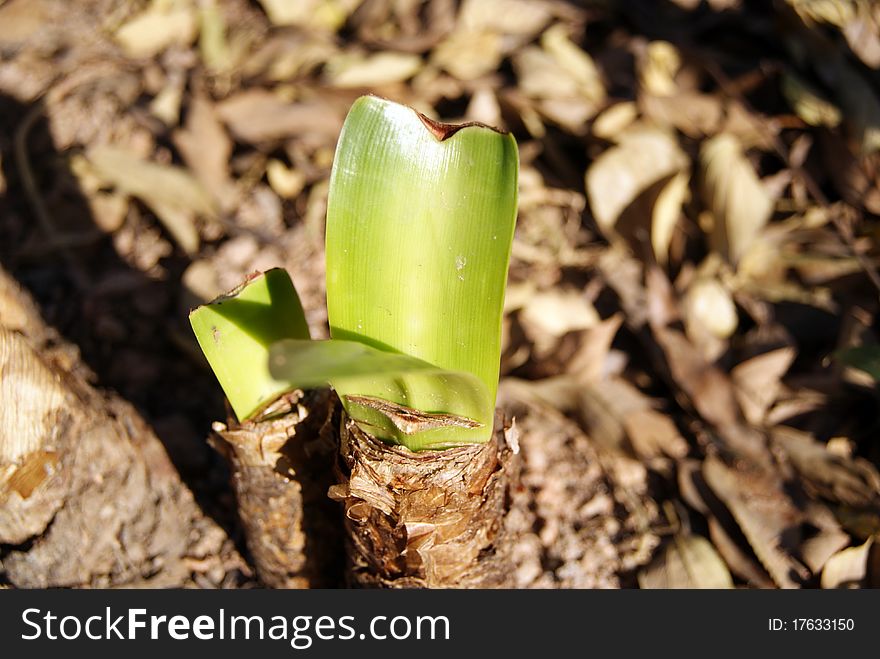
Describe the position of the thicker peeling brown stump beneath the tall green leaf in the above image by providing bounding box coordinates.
[331,413,519,588]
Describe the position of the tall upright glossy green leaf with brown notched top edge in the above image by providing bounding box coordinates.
[327,96,518,448]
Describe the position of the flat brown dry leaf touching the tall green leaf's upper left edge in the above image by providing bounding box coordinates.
[216,89,342,143]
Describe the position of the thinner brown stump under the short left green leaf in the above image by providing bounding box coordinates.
[214,390,343,588]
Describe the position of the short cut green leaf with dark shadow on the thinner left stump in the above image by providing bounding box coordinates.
[189,268,309,421]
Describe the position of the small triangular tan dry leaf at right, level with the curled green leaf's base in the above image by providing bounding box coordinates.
[730,347,797,426]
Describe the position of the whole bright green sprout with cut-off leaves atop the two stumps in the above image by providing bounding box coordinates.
[191,96,518,450]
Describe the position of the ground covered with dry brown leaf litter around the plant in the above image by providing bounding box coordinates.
[0,0,880,588]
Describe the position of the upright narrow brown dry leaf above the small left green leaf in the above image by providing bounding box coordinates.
[172,94,238,211]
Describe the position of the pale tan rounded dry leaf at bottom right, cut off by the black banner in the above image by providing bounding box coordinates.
[638,533,733,588]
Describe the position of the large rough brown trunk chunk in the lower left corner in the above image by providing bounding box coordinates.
[0,270,229,587]
